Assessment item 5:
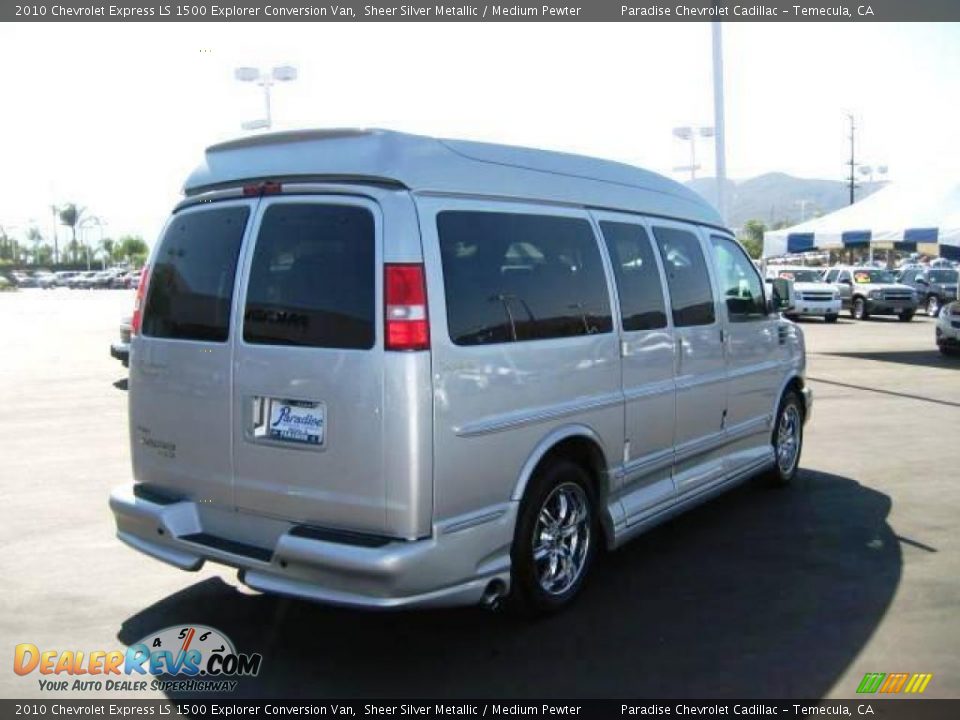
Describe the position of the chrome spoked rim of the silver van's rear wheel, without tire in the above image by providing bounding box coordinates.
[533,482,591,595]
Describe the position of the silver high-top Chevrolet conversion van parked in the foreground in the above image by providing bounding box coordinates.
[110,130,812,613]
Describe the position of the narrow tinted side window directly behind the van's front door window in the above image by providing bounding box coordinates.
[653,227,716,327]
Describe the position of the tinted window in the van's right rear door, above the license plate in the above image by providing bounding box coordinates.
[243,203,376,349]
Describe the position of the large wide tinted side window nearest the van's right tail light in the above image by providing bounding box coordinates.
[437,210,613,345]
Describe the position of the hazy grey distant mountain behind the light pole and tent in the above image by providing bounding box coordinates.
[686,173,886,228]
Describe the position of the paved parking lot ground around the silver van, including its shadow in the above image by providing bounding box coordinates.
[0,289,960,698]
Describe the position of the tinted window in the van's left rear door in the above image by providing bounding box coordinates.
[143,207,250,342]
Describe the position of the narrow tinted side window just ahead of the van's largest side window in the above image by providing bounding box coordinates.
[600,221,667,332]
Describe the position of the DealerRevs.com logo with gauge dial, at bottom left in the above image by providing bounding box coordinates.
[13,625,263,692]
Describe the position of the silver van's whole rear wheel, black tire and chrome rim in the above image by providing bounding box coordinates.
[507,460,600,617]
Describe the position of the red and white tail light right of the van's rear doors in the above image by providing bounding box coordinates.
[384,263,430,350]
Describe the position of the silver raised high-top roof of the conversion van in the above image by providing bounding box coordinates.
[184,130,722,226]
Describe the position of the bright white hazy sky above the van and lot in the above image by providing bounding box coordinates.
[0,23,960,243]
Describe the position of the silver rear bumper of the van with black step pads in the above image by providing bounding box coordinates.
[110,485,517,609]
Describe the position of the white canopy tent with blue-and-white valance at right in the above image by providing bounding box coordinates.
[763,180,960,260]
